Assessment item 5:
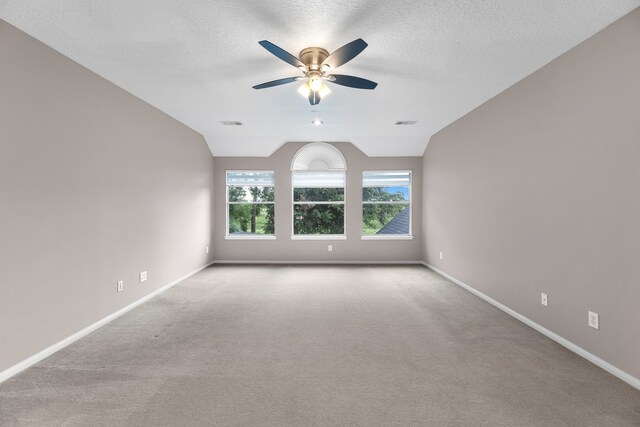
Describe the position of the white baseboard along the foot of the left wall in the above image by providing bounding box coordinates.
[0,261,213,383]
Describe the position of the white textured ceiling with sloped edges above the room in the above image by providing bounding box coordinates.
[0,0,640,156]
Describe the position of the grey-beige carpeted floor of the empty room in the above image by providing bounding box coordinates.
[0,266,640,427]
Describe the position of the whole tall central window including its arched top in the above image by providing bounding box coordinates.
[291,142,347,239]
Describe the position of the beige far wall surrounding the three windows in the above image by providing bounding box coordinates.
[214,142,422,262]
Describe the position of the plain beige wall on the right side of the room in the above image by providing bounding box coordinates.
[423,9,640,378]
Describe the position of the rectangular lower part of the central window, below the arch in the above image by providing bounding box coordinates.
[292,171,345,237]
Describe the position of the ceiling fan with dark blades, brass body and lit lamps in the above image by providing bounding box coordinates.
[253,39,378,105]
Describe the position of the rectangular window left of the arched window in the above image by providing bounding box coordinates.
[227,171,275,238]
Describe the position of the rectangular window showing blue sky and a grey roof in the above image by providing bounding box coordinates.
[362,171,411,239]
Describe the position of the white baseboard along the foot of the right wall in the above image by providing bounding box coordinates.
[421,262,640,390]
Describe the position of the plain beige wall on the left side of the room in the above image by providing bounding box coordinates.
[0,21,213,372]
